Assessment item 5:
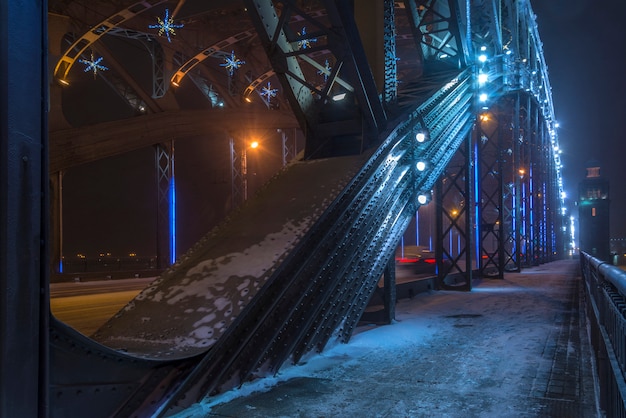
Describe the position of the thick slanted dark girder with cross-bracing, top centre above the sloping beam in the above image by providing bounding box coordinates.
[244,0,386,158]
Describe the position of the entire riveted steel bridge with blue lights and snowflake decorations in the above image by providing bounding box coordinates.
[0,0,565,417]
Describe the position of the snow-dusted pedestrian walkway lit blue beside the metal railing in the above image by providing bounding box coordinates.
[177,260,601,418]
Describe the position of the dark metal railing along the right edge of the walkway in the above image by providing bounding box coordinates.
[580,252,626,417]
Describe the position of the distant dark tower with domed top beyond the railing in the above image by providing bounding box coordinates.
[578,161,611,261]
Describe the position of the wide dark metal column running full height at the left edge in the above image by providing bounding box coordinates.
[0,0,50,417]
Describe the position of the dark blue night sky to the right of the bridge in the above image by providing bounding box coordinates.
[531,0,626,238]
